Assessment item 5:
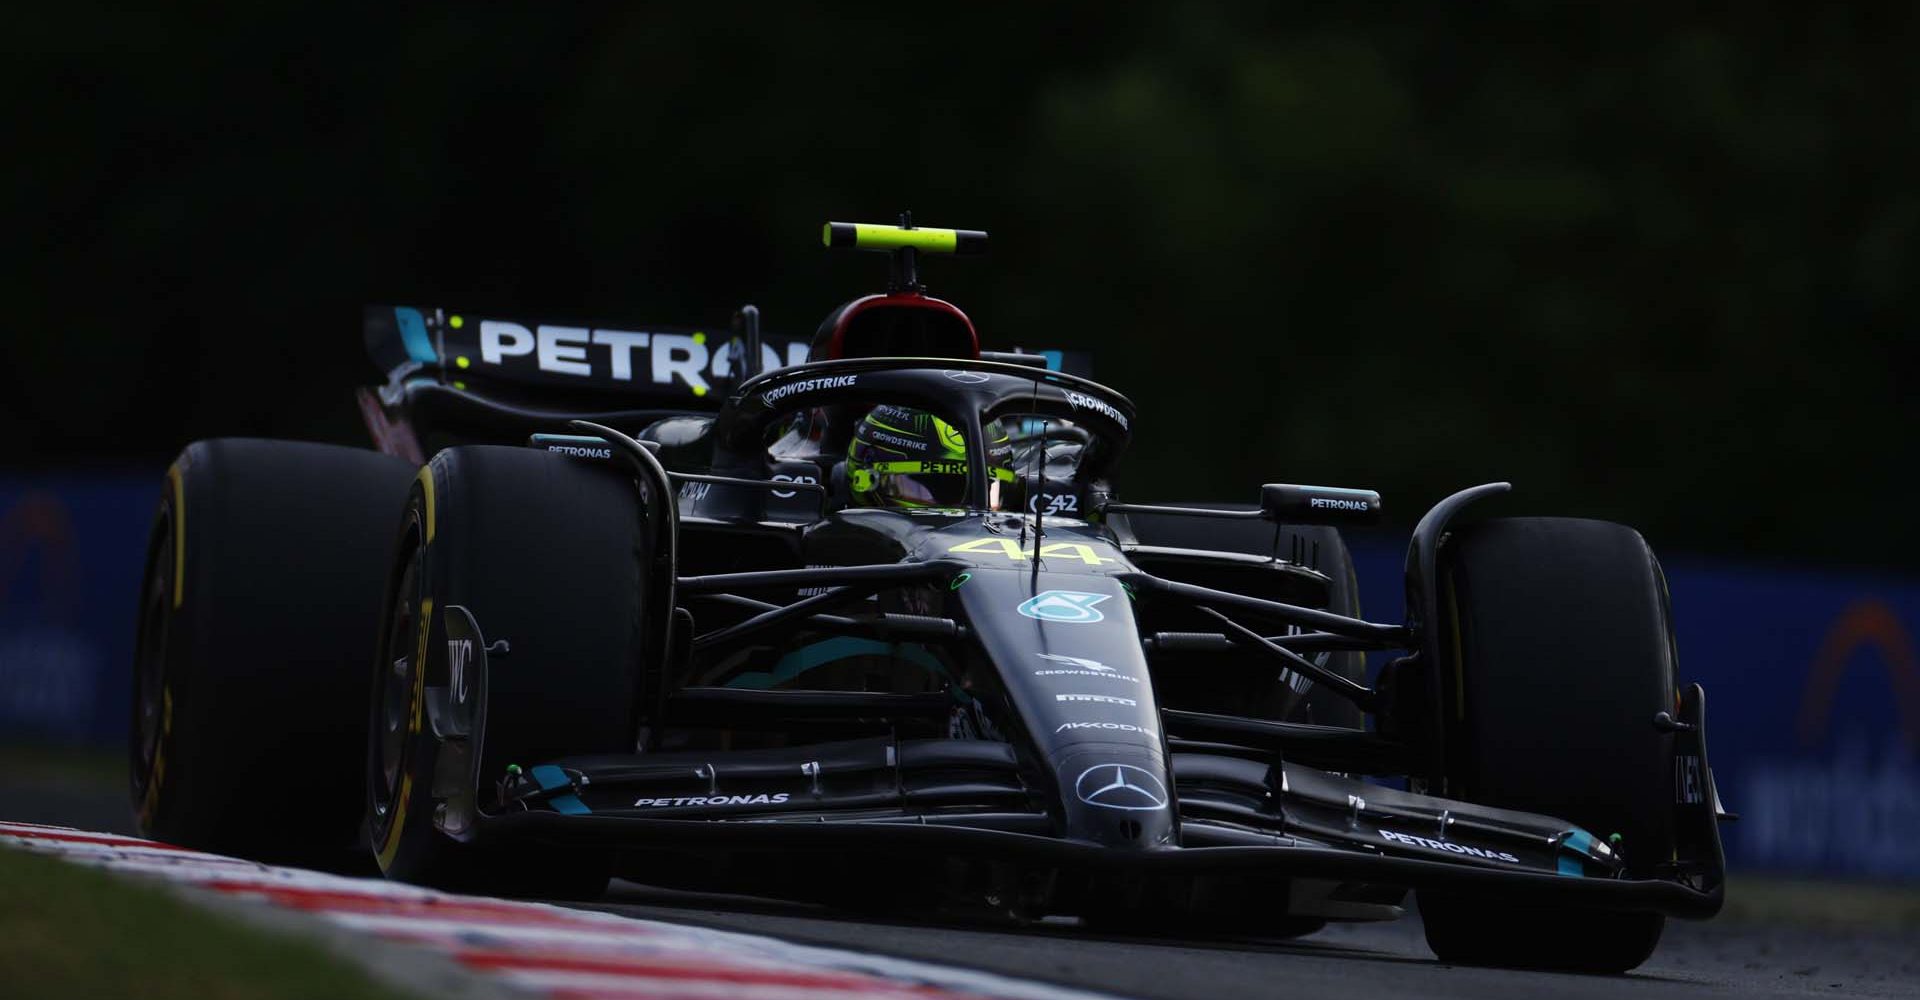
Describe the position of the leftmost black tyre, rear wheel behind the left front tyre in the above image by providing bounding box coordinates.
[127,438,413,868]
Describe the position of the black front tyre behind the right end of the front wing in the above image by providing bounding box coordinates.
[1419,518,1676,973]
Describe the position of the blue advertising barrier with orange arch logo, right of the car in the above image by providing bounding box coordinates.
[1668,560,1920,879]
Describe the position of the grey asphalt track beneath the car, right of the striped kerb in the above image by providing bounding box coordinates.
[589,883,1920,1000]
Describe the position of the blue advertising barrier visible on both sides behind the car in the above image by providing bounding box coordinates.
[0,479,1920,881]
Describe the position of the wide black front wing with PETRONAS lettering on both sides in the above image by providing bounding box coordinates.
[467,685,1724,917]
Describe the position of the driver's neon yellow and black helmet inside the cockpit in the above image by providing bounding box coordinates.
[847,405,1014,511]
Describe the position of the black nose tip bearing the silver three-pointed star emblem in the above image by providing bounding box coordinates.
[1054,743,1177,848]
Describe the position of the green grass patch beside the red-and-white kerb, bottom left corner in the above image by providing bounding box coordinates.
[0,848,399,1000]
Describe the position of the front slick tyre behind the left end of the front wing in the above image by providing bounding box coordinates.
[363,447,651,898]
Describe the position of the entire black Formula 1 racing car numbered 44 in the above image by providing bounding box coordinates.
[131,219,1724,971]
